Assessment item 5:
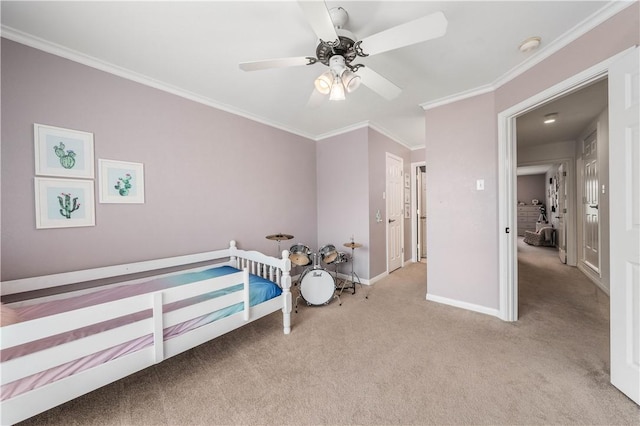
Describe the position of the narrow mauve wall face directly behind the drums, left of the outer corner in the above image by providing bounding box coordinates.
[316,128,370,280]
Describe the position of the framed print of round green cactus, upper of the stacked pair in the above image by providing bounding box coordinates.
[33,123,94,179]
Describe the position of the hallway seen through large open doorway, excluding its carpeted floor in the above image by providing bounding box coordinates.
[516,77,609,294]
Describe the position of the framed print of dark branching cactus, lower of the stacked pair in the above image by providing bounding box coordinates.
[35,177,96,229]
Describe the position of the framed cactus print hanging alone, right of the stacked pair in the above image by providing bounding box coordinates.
[98,158,144,204]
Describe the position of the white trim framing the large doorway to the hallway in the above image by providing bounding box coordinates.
[498,47,635,321]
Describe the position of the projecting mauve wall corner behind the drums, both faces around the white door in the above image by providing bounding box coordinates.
[317,127,411,280]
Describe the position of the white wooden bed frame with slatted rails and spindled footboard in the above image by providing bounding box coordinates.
[0,241,292,424]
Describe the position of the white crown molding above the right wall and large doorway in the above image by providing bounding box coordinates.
[419,0,638,111]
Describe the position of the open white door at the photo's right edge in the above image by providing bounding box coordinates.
[609,48,640,404]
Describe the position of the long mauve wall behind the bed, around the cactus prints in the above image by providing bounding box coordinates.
[1,39,317,280]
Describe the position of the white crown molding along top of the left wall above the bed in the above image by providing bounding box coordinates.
[0,25,315,140]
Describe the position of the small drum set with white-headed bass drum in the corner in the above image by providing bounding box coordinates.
[289,242,362,312]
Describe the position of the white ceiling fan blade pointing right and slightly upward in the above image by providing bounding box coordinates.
[361,12,448,55]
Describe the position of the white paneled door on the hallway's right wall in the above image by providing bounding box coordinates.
[582,130,600,272]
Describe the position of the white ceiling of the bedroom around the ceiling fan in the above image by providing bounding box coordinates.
[1,1,630,148]
